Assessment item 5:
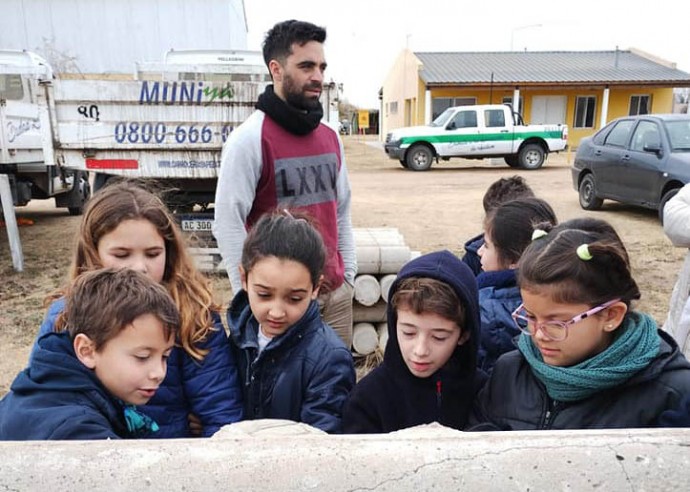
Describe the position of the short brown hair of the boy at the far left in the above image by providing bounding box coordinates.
[64,268,180,351]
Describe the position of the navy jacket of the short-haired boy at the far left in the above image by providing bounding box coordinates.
[0,332,128,441]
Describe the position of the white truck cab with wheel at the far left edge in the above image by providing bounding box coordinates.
[0,50,90,215]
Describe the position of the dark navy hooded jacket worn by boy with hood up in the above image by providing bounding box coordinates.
[343,251,486,434]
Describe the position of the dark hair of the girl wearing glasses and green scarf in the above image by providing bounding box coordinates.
[518,219,640,307]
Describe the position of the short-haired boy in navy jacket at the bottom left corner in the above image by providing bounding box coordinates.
[0,270,180,440]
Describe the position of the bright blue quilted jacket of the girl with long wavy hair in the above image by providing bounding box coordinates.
[29,299,243,439]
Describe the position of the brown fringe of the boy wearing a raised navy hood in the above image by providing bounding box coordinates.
[390,277,465,330]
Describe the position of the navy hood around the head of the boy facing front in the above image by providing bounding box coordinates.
[383,250,481,379]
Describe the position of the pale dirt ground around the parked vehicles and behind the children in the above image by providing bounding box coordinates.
[0,136,686,395]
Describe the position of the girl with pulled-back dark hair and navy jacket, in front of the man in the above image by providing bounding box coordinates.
[228,211,355,433]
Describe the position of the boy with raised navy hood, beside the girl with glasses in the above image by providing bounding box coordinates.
[343,251,485,434]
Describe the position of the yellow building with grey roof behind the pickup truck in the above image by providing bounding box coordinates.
[380,49,690,147]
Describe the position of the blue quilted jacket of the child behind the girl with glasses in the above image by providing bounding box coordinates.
[477,270,522,373]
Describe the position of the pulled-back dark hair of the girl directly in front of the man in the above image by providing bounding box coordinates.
[242,211,326,287]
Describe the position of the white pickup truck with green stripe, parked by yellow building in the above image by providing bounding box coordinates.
[384,104,568,171]
